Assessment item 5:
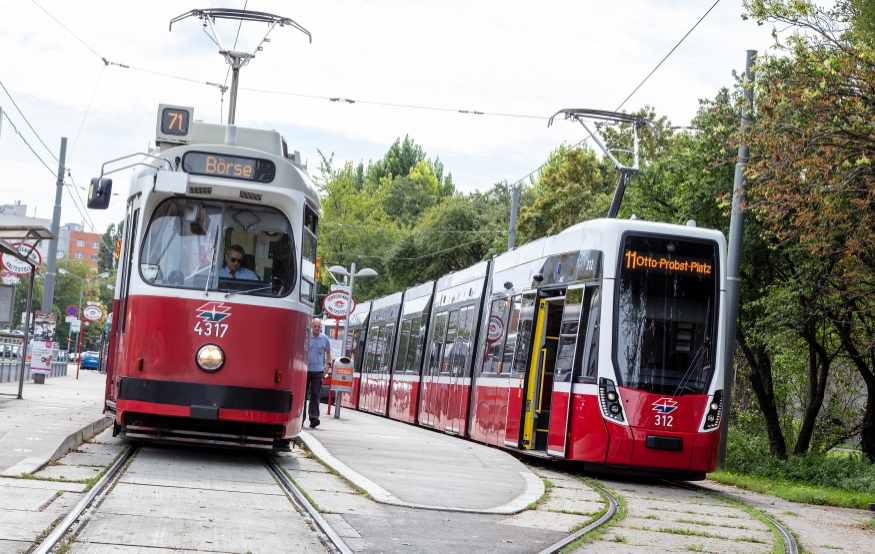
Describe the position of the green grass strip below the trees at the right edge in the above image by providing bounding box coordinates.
[708,471,875,510]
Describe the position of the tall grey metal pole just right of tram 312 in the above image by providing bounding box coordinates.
[717,50,757,467]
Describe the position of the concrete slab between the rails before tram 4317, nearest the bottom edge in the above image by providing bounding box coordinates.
[79,514,326,554]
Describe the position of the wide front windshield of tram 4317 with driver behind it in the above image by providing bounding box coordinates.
[140,198,295,296]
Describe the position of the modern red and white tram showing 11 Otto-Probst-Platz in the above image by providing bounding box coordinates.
[345,219,726,479]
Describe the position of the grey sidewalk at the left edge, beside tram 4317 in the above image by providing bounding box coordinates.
[0,365,111,476]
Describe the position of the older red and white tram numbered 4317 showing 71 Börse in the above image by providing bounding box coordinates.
[89,105,319,448]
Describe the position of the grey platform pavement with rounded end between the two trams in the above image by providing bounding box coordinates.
[301,405,544,514]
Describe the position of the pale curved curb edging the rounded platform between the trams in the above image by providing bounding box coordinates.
[300,431,545,515]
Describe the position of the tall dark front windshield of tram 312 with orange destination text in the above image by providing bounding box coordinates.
[614,235,718,395]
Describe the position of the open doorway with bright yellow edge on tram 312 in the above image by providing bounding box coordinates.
[522,296,565,450]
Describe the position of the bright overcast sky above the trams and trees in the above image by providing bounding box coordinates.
[0,0,772,232]
